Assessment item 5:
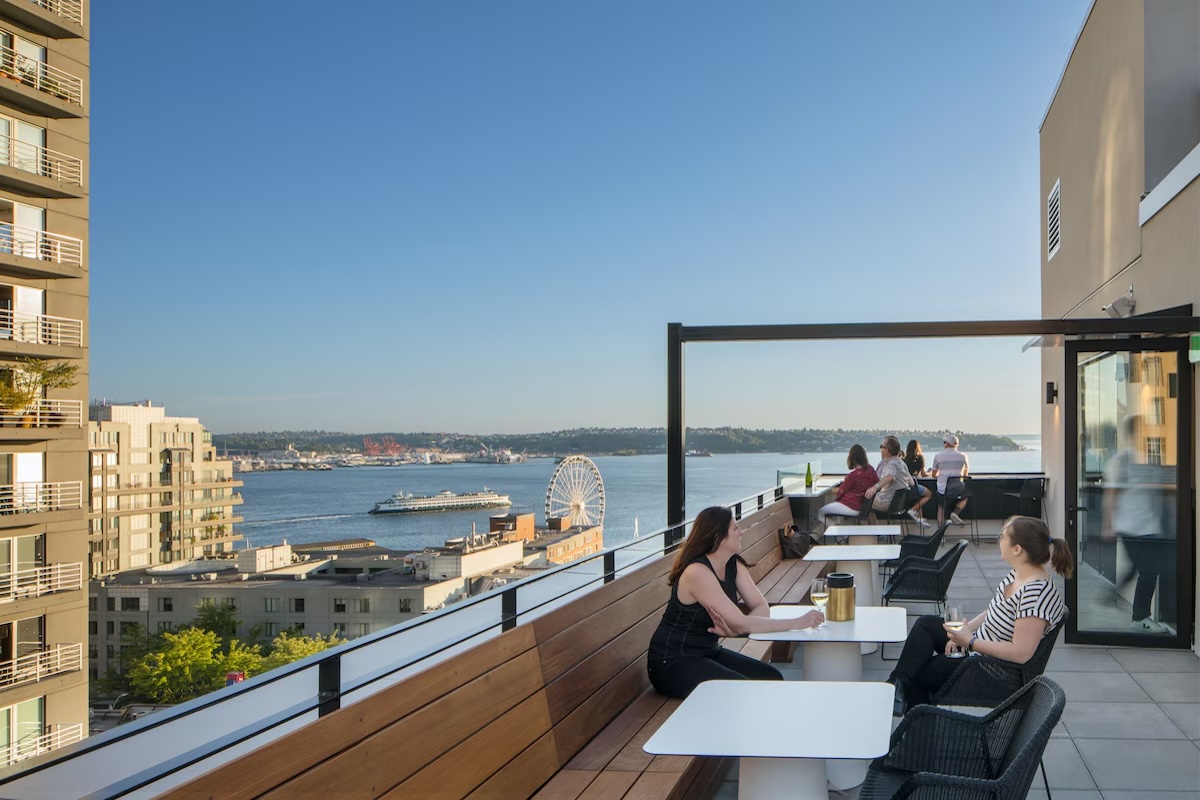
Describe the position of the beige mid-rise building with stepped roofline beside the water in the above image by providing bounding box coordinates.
[88,401,242,578]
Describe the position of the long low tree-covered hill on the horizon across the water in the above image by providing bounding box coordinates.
[212,428,1020,456]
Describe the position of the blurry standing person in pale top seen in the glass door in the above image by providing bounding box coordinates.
[1100,414,1175,633]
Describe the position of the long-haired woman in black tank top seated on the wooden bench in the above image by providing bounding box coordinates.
[647,506,823,697]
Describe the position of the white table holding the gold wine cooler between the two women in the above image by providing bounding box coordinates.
[750,606,908,680]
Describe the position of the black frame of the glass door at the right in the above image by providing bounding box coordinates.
[1061,337,1196,649]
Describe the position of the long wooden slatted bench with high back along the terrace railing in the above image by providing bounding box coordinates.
[162,500,815,800]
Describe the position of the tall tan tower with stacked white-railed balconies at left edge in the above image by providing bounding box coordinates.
[0,0,90,768]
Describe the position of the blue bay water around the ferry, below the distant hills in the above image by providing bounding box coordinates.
[238,450,1042,551]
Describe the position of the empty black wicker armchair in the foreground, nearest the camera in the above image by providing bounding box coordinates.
[858,678,1067,800]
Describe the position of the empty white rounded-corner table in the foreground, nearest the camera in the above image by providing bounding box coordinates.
[642,680,895,800]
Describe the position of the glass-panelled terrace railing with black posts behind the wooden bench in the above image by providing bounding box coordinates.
[0,487,782,798]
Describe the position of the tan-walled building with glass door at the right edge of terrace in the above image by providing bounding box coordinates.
[1040,0,1200,648]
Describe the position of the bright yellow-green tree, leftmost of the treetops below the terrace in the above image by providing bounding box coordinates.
[128,627,226,703]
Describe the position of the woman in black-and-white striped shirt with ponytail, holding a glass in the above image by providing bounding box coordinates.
[888,517,1074,716]
